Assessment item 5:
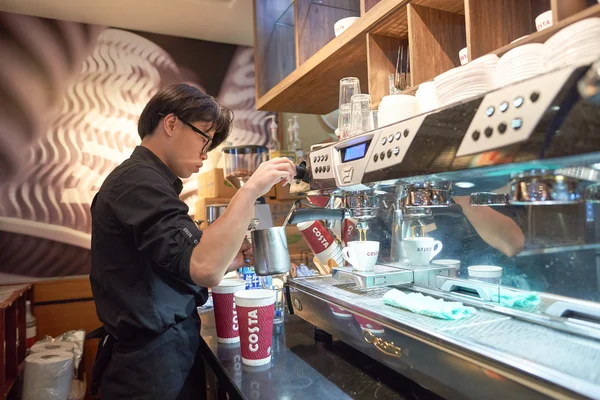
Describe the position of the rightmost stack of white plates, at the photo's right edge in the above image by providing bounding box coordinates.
[543,18,600,71]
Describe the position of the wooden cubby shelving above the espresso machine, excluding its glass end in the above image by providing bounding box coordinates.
[256,0,600,114]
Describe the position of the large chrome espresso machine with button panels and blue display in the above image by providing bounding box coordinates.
[287,62,600,399]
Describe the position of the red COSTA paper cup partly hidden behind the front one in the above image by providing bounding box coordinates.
[212,279,246,343]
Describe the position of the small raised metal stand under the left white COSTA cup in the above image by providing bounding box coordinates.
[331,265,414,290]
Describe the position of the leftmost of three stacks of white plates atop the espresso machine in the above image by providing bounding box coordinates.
[433,63,493,106]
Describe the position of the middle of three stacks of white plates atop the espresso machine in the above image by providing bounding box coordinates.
[496,43,544,87]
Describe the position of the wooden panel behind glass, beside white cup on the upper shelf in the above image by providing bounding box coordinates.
[295,0,360,66]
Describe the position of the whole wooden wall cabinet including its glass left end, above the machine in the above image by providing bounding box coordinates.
[254,0,600,114]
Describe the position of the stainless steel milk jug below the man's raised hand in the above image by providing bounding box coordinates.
[252,226,292,276]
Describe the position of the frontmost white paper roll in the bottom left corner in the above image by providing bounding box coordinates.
[23,350,73,400]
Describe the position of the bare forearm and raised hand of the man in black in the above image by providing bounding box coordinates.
[190,158,296,287]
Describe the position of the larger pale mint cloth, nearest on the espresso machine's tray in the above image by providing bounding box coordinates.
[383,289,477,320]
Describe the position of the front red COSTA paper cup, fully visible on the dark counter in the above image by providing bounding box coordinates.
[235,289,275,366]
